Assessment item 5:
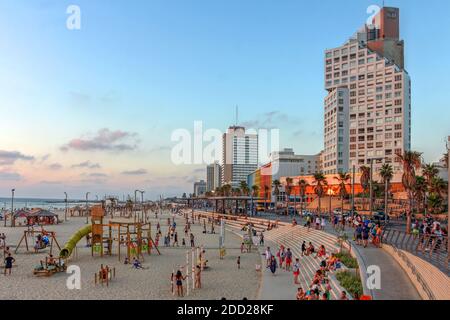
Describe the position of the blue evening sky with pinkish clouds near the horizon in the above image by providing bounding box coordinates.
[0,0,450,199]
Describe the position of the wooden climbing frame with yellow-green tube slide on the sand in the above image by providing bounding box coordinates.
[60,206,161,261]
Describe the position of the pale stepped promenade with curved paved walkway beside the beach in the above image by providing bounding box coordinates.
[192,210,421,300]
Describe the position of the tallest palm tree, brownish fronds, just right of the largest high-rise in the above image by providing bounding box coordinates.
[397,151,422,233]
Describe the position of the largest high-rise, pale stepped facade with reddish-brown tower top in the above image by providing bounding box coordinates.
[323,7,411,174]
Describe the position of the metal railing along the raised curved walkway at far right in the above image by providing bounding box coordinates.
[382,228,450,276]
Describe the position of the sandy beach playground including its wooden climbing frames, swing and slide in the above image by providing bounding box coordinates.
[0,211,260,300]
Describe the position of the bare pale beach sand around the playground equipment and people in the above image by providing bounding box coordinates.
[0,212,261,300]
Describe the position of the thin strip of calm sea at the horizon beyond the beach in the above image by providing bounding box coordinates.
[0,198,98,210]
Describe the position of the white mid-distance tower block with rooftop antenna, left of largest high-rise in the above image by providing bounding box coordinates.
[221,126,258,188]
